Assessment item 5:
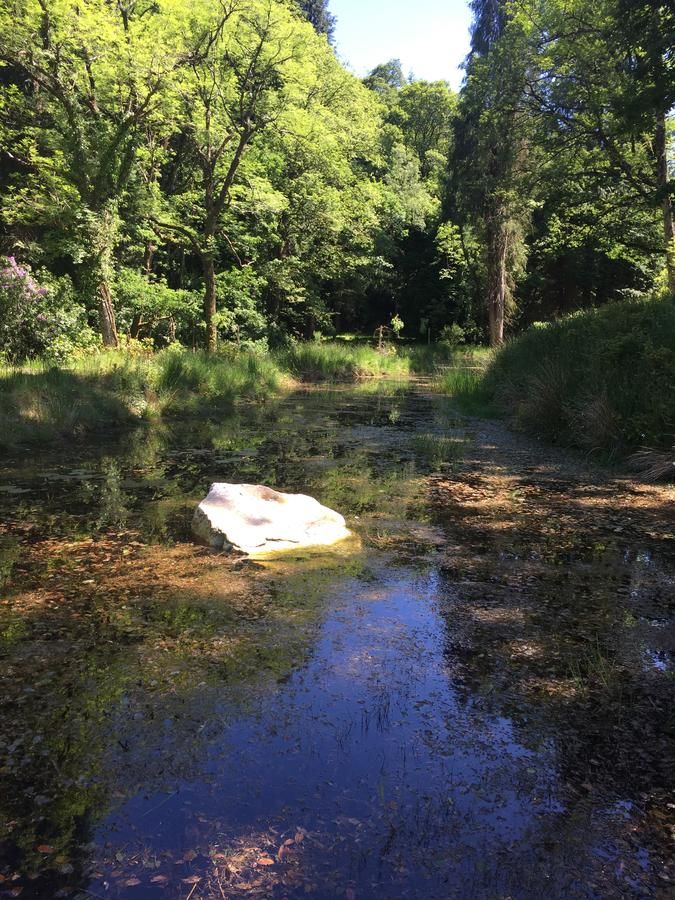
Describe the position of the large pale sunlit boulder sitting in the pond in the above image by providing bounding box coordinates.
[192,484,350,556]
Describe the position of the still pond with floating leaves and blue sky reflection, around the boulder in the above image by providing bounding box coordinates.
[0,383,675,900]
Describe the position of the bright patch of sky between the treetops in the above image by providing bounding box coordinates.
[329,0,471,88]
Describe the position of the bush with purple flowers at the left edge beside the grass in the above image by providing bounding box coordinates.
[0,256,95,363]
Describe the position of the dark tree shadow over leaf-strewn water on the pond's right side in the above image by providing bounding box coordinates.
[432,446,675,896]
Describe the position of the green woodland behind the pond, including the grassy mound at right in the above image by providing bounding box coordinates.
[0,0,675,458]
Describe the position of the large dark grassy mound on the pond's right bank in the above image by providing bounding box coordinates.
[482,298,675,453]
